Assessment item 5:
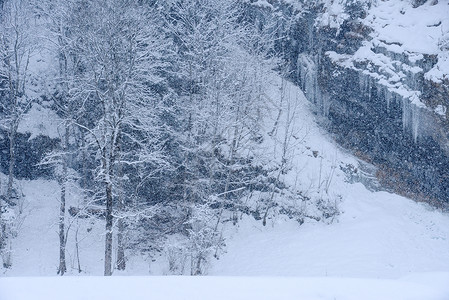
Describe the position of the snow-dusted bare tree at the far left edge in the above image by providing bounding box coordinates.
[0,0,35,267]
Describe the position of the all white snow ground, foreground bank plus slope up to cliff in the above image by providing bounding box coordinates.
[0,72,449,300]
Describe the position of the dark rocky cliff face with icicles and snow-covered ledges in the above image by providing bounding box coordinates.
[247,0,449,203]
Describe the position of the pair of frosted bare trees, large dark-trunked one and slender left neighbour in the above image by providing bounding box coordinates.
[34,0,172,275]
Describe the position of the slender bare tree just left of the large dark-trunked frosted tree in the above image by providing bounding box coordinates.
[35,0,87,276]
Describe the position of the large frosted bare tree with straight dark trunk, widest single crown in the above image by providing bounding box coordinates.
[71,0,163,276]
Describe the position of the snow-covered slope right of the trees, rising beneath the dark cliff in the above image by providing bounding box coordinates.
[210,73,449,283]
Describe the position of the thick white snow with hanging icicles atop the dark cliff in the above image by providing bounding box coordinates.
[321,0,449,141]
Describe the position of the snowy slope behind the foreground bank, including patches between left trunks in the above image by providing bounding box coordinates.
[3,71,449,278]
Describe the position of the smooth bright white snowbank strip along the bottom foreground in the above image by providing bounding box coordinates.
[0,273,449,300]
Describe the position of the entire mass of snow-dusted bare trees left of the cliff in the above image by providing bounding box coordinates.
[0,0,322,275]
